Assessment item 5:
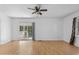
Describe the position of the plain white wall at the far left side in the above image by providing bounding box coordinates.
[0,12,11,44]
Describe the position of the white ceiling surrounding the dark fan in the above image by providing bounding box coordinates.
[0,4,79,18]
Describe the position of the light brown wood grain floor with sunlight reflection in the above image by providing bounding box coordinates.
[0,41,79,55]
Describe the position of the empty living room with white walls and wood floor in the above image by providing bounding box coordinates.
[0,4,79,55]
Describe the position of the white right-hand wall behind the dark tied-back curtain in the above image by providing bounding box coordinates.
[63,12,79,47]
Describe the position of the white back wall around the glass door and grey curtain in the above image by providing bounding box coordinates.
[11,18,62,40]
